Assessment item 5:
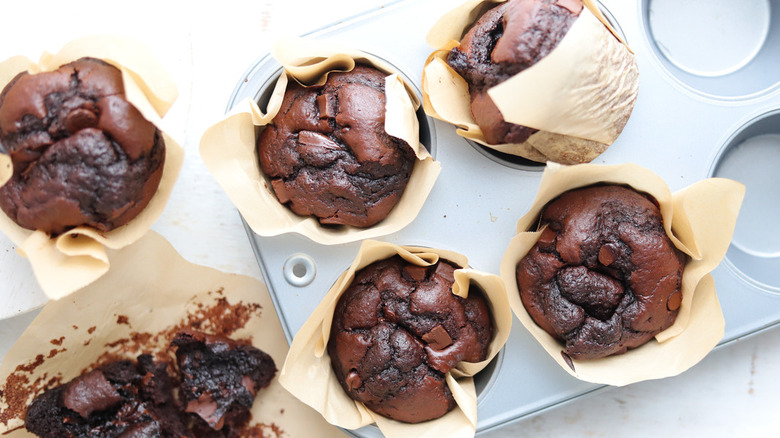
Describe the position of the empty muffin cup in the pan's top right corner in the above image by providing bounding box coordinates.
[641,0,780,100]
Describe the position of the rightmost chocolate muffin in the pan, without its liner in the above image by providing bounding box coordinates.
[517,185,686,359]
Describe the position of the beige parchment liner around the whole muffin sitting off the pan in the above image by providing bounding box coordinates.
[0,36,184,299]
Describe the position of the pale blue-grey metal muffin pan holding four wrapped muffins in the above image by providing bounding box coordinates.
[228,0,780,437]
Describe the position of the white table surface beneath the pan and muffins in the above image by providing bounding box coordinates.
[0,0,780,438]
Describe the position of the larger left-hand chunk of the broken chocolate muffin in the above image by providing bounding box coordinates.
[25,355,193,438]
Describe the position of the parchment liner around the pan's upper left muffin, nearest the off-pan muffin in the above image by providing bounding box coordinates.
[200,38,441,245]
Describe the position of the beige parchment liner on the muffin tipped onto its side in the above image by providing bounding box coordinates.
[422,0,639,164]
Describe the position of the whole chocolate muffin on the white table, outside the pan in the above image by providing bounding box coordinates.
[0,58,165,235]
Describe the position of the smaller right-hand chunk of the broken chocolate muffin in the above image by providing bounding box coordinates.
[172,331,276,437]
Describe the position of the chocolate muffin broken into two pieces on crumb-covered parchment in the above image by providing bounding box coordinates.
[25,331,276,438]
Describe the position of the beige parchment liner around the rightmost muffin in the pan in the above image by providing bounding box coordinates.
[501,163,745,386]
